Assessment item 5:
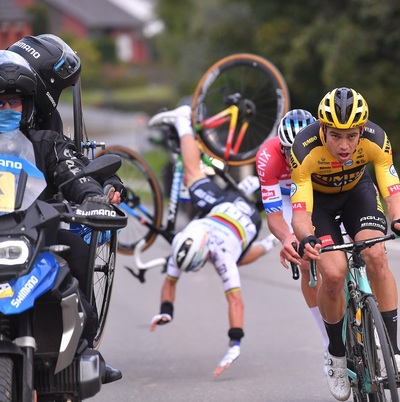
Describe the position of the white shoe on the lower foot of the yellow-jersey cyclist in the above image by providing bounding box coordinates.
[324,352,350,401]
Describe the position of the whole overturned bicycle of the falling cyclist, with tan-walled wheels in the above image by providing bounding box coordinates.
[99,53,290,282]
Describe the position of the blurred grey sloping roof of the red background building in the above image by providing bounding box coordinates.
[39,0,142,28]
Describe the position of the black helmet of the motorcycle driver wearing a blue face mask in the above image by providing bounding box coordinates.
[0,50,37,133]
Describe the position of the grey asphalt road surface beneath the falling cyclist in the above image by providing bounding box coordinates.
[83,229,400,402]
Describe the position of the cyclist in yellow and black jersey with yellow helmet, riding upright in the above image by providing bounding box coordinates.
[291,88,400,401]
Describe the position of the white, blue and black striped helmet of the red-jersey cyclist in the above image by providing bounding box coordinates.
[278,109,315,148]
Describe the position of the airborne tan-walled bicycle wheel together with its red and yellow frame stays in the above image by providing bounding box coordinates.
[192,54,290,165]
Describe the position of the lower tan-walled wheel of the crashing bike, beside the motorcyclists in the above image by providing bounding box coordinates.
[96,146,163,254]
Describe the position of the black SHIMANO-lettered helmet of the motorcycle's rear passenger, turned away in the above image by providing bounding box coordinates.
[7,34,81,115]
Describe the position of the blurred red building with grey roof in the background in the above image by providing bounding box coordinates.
[0,0,149,63]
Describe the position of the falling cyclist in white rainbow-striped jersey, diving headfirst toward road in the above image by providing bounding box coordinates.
[149,106,273,377]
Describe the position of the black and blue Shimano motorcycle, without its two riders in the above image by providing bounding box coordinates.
[0,130,126,402]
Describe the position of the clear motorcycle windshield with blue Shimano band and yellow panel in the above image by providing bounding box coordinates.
[0,130,47,216]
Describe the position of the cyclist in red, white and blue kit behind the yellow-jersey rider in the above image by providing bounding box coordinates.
[256,109,329,350]
